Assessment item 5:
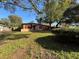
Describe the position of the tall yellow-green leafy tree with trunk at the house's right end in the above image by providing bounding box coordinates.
[45,0,72,27]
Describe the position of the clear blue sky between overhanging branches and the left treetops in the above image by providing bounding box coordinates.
[0,0,79,23]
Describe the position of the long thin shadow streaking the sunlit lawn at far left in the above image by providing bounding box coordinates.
[0,33,30,40]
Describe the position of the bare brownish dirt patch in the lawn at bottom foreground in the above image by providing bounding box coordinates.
[9,47,57,59]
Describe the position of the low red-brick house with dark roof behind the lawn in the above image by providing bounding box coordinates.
[21,23,50,32]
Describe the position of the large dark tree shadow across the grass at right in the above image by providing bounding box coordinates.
[35,31,79,52]
